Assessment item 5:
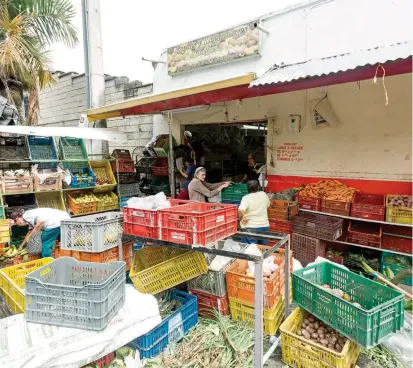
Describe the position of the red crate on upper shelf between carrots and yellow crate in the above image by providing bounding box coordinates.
[351,192,386,221]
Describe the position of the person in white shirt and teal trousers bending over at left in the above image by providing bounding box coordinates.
[10,208,70,257]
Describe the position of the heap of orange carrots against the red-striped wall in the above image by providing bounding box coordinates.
[299,180,357,202]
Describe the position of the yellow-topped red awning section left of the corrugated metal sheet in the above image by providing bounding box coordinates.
[87,73,255,121]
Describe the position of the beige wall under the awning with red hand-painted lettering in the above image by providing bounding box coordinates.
[173,74,412,181]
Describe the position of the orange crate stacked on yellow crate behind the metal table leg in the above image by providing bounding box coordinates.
[226,247,292,308]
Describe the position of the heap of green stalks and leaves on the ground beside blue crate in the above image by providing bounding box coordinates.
[143,313,260,368]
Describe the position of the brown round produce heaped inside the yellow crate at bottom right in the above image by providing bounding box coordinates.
[296,315,347,353]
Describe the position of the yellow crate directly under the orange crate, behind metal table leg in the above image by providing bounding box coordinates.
[228,296,284,335]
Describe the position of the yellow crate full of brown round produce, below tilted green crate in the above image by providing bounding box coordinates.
[280,308,360,368]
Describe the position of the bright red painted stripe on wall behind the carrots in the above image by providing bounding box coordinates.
[267,175,412,195]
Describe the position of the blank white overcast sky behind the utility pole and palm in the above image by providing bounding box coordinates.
[51,0,302,83]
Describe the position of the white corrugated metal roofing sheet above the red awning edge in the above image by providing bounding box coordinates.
[250,41,413,87]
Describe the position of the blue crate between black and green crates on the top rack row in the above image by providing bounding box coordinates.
[27,135,59,169]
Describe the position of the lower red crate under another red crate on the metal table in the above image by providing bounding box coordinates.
[160,221,237,246]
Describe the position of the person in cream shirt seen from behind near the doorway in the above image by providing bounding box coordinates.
[238,180,270,245]
